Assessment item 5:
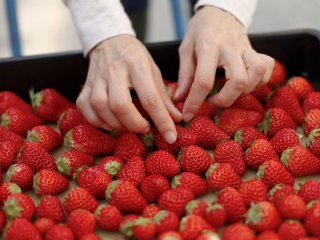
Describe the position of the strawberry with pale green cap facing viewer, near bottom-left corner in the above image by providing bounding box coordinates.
[3,193,36,220]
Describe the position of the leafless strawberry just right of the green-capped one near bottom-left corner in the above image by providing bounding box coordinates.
[36,195,64,223]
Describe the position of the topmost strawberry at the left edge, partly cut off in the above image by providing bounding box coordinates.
[0,91,33,115]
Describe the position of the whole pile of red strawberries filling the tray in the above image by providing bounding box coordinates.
[0,61,320,240]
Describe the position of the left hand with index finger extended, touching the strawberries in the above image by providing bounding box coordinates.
[77,35,182,143]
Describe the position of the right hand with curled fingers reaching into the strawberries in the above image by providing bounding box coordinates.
[174,6,274,122]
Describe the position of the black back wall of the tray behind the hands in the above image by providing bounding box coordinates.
[0,29,320,100]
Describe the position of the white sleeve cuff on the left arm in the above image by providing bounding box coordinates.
[64,0,135,56]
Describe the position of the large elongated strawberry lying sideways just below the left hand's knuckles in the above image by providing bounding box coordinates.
[64,124,115,156]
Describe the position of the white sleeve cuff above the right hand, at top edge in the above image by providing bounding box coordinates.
[195,0,257,28]
